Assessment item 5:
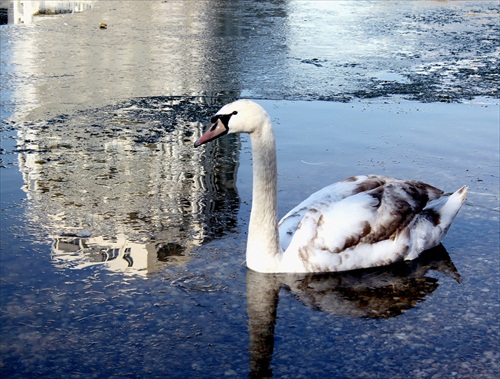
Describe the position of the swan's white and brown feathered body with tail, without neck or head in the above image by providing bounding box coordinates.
[279,175,467,272]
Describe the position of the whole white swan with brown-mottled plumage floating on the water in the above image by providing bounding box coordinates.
[194,99,467,273]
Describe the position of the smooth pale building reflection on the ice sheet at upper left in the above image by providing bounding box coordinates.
[2,1,245,120]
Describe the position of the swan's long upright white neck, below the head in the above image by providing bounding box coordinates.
[246,118,282,272]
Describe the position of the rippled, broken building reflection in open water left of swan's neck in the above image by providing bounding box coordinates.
[19,97,239,274]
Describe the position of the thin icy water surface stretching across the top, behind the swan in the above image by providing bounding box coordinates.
[0,0,500,119]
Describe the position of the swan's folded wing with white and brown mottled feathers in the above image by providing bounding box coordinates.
[280,177,442,271]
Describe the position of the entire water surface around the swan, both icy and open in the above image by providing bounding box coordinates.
[0,1,500,378]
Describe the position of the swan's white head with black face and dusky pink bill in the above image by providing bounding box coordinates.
[194,100,269,147]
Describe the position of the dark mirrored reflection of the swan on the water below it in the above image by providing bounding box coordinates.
[247,245,460,378]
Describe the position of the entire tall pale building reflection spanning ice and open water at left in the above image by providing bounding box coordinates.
[12,2,250,275]
